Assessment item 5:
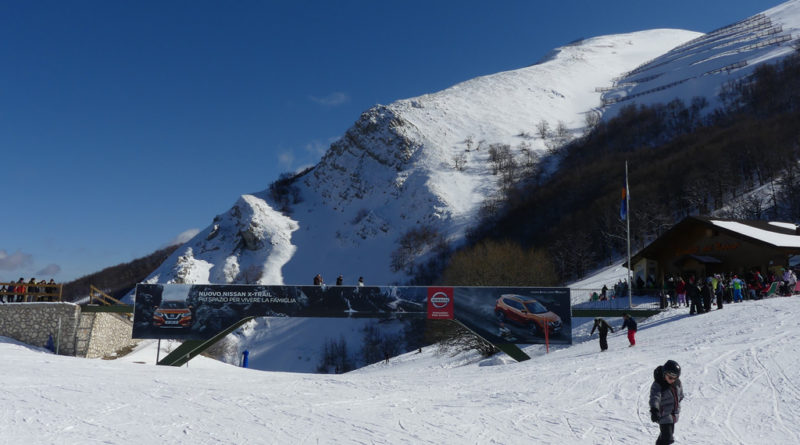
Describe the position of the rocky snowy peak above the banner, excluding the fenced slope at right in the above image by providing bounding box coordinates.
[148,29,699,284]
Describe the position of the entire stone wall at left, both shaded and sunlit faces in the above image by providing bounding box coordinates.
[0,303,136,358]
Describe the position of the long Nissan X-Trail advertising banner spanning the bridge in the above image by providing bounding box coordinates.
[133,284,572,344]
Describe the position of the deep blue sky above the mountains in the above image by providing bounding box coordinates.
[0,0,782,281]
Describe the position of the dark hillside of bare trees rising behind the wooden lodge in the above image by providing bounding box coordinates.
[443,53,800,280]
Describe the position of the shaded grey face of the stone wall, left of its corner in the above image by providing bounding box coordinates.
[0,303,81,355]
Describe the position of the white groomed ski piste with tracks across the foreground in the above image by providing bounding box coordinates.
[0,297,800,445]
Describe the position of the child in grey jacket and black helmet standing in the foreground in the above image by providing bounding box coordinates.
[650,360,683,445]
